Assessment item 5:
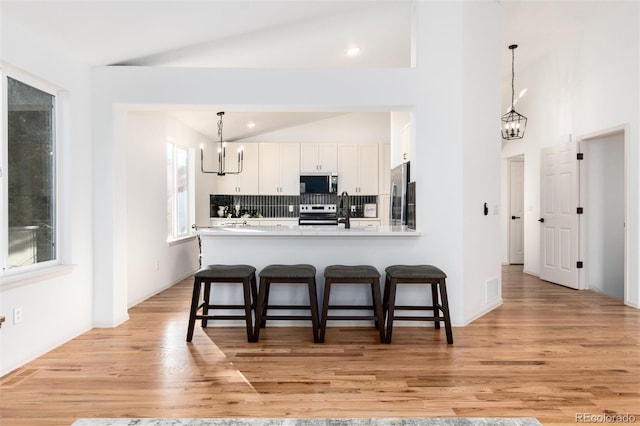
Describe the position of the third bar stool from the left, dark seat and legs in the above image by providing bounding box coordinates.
[319,265,386,343]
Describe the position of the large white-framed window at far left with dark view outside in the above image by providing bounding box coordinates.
[0,74,58,272]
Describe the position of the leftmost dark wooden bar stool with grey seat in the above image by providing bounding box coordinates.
[187,265,258,342]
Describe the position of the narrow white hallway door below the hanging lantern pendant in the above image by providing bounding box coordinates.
[509,161,524,265]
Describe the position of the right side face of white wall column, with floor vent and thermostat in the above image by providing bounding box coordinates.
[460,2,502,321]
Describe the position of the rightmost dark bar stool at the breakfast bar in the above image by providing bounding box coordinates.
[382,265,453,344]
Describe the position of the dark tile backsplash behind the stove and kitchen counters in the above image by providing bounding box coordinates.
[209,194,377,218]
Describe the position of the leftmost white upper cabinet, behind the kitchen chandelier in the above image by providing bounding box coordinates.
[216,143,260,195]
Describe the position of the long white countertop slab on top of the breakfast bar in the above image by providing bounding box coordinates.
[196,225,420,237]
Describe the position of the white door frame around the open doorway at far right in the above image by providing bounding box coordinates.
[577,125,632,305]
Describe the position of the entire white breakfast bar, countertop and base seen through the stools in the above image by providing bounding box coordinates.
[195,224,438,332]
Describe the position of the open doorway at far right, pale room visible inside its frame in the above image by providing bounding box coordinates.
[580,131,626,300]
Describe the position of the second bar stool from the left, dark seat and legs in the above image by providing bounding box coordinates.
[254,264,319,343]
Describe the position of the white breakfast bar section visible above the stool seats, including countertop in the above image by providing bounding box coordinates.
[196,224,425,277]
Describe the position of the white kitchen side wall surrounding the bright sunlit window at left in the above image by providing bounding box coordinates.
[127,112,201,307]
